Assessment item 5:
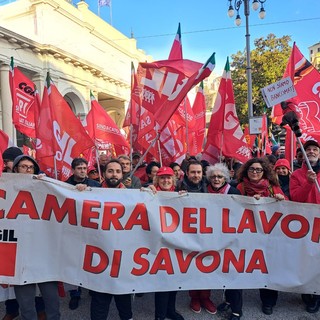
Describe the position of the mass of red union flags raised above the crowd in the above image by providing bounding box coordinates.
[0,24,320,180]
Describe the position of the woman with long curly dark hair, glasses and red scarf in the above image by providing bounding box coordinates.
[237,158,287,315]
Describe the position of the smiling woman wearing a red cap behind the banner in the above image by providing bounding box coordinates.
[149,167,184,320]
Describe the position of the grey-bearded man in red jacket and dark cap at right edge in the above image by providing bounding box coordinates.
[289,140,320,313]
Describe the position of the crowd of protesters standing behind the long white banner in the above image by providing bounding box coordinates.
[2,140,320,320]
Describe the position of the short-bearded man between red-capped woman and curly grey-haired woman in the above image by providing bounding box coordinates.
[176,160,217,314]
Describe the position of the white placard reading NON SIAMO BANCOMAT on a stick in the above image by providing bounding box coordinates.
[261,77,297,108]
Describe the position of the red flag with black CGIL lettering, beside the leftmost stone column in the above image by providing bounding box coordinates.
[9,57,36,138]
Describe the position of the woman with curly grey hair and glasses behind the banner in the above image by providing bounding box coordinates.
[206,163,242,320]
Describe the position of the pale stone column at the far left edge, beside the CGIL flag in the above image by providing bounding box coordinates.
[0,64,16,143]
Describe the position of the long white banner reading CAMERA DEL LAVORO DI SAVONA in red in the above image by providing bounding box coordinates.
[0,174,320,300]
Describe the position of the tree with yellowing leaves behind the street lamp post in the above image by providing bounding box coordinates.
[231,33,292,124]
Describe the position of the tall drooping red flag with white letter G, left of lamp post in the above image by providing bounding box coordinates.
[202,59,251,163]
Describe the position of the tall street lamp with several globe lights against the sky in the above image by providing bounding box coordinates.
[228,0,266,119]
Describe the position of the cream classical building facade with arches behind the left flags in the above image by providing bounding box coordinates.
[0,0,152,141]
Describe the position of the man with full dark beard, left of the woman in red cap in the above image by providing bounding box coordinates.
[90,159,132,320]
